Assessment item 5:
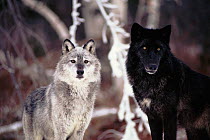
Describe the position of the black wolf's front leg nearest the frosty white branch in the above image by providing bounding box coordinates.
[148,116,163,140]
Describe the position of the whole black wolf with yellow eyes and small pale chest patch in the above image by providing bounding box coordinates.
[126,23,210,140]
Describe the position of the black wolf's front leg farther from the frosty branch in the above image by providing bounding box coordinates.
[163,111,177,140]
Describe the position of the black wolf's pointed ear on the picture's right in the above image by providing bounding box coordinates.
[160,25,171,44]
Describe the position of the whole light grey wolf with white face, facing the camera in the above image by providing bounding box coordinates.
[22,39,101,140]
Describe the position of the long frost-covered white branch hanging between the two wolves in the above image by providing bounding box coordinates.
[96,0,150,140]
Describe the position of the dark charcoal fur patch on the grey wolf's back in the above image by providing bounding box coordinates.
[24,87,47,114]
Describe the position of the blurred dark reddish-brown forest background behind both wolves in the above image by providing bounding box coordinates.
[0,0,210,140]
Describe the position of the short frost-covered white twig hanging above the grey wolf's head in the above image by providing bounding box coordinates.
[69,0,85,45]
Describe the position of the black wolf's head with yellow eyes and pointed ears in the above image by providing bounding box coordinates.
[130,23,171,74]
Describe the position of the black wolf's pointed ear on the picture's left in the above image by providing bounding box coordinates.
[131,23,144,42]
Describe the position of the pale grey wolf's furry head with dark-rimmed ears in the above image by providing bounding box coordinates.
[54,39,101,83]
